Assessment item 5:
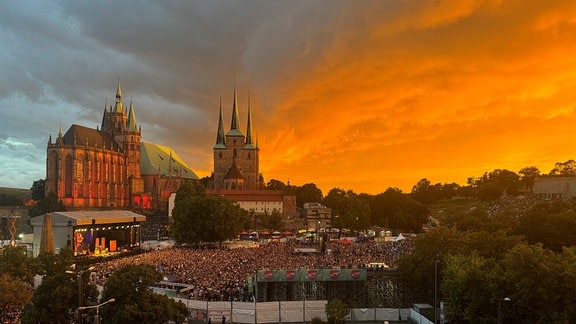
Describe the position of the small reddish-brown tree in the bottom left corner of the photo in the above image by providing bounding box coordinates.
[0,273,32,323]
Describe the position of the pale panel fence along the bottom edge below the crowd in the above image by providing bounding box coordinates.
[174,298,410,324]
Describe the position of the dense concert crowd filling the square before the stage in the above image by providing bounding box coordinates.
[94,238,414,301]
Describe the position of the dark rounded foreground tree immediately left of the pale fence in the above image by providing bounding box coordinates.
[100,265,188,323]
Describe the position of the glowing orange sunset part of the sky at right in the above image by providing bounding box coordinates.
[232,1,576,194]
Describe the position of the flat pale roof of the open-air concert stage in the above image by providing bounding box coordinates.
[30,210,146,226]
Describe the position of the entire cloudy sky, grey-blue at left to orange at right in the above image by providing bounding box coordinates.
[0,0,576,194]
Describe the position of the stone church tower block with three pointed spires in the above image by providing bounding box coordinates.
[212,83,262,190]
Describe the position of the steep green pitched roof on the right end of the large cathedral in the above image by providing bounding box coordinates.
[140,142,199,180]
